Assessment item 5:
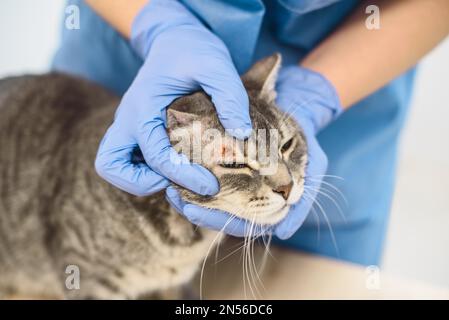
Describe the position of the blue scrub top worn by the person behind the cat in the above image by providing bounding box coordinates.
[53,0,415,265]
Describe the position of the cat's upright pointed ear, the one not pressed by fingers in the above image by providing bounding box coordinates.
[242,53,282,102]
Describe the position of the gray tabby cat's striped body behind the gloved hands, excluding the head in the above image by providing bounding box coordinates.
[0,54,305,298]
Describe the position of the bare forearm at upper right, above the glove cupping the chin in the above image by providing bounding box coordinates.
[300,0,449,108]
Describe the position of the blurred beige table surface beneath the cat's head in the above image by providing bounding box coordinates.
[201,239,449,299]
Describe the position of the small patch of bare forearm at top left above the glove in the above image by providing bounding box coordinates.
[86,0,148,38]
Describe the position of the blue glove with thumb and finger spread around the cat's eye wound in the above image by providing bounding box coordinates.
[95,0,251,196]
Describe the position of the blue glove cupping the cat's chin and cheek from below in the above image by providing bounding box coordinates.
[166,66,342,239]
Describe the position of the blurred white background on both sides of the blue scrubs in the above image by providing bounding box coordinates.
[0,0,449,286]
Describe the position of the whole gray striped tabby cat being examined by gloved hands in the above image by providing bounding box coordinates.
[0,54,307,299]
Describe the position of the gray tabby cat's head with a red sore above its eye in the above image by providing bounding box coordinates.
[167,54,307,225]
